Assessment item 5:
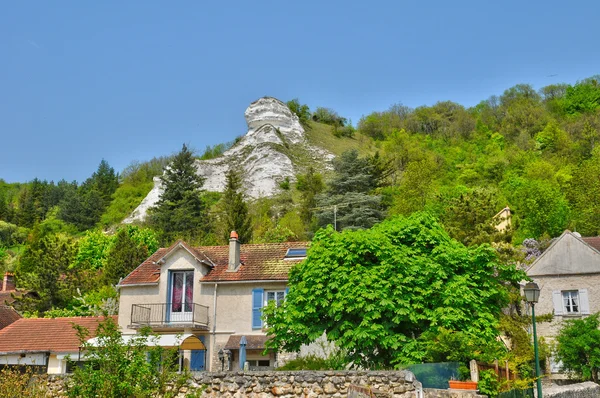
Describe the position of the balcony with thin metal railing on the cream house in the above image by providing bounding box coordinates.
[130,303,208,330]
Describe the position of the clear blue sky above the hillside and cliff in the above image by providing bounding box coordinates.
[0,0,600,182]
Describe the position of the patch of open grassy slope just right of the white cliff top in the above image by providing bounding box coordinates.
[305,121,376,156]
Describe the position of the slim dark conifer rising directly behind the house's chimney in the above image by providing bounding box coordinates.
[221,169,252,243]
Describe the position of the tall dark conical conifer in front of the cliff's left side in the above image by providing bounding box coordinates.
[149,144,208,240]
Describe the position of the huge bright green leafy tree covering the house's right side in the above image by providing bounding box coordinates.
[266,213,526,367]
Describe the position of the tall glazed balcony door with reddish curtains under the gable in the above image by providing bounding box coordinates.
[169,271,194,323]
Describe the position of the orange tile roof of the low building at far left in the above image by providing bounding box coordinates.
[0,316,116,353]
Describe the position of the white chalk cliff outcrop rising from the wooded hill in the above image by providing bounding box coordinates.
[123,97,334,223]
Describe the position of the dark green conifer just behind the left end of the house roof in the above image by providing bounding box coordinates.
[103,228,148,285]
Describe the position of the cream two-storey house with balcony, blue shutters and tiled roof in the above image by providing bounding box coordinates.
[118,232,307,371]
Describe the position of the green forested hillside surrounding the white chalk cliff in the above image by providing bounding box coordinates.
[0,76,600,315]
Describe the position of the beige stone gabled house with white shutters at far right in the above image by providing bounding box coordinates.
[527,230,600,378]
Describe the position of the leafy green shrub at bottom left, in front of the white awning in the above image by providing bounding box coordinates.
[66,318,189,398]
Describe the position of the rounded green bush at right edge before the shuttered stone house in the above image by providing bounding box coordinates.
[556,314,600,383]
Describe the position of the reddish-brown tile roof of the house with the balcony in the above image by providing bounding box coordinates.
[119,242,308,286]
